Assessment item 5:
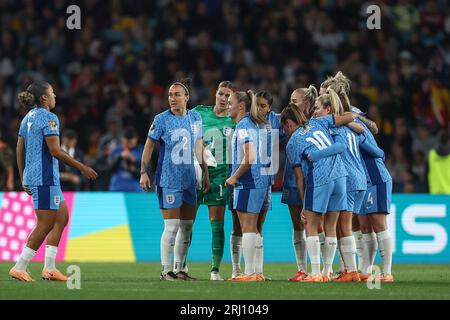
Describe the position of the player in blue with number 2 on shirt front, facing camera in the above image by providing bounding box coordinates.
[140,79,209,281]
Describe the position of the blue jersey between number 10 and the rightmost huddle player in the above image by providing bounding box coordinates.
[331,126,367,192]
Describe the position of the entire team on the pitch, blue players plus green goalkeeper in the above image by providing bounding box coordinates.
[9,72,394,282]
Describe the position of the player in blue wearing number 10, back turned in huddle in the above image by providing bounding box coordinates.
[281,100,354,282]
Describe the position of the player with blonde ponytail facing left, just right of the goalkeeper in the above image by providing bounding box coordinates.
[226,91,271,282]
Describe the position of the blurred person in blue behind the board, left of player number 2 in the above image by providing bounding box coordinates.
[109,127,144,192]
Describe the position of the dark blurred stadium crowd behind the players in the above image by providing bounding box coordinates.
[0,0,450,193]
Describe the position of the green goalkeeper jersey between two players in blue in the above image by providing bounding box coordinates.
[193,105,236,178]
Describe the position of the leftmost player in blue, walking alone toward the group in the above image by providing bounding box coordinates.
[9,82,97,282]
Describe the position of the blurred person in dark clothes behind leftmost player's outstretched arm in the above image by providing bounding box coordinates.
[59,129,86,191]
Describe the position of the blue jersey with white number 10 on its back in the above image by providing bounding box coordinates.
[287,118,347,187]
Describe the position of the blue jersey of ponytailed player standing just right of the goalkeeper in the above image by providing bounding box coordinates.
[231,116,272,189]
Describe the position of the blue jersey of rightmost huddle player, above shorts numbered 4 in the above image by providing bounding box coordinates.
[356,119,392,187]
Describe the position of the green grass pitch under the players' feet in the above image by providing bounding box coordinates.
[0,263,450,300]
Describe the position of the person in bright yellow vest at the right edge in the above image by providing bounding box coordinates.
[428,131,450,194]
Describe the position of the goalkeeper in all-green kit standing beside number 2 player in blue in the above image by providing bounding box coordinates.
[193,81,236,280]
